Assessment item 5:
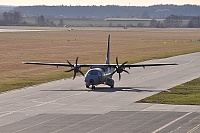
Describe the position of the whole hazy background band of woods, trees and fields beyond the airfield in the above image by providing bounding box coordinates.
[0,5,200,28]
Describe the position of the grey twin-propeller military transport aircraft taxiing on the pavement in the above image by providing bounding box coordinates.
[23,34,177,90]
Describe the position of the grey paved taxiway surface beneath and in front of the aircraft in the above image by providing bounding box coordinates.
[0,52,200,133]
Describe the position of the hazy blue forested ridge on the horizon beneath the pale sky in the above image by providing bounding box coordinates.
[13,5,200,19]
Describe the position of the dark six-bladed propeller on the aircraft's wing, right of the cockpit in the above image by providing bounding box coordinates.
[111,57,129,80]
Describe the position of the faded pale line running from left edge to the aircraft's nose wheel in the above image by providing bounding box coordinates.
[0,92,86,118]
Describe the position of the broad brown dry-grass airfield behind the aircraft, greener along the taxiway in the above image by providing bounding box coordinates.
[0,27,200,95]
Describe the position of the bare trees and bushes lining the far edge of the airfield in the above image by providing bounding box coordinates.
[0,11,200,28]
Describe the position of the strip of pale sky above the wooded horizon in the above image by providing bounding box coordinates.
[0,0,200,6]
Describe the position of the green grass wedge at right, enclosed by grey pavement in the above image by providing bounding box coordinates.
[138,78,200,105]
